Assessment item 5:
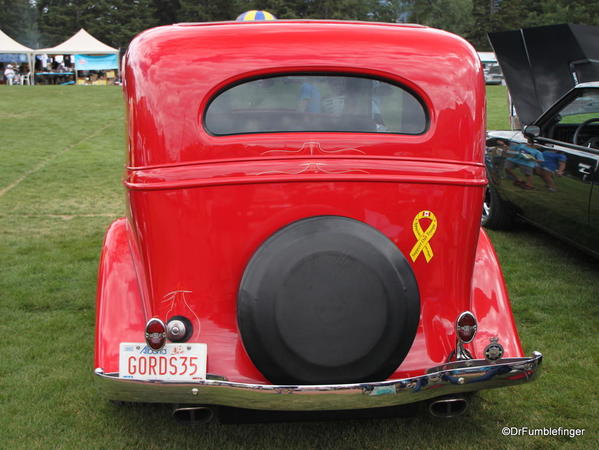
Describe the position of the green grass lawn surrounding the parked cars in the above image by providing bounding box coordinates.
[0,86,599,449]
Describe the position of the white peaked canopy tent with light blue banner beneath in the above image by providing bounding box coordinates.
[33,28,119,82]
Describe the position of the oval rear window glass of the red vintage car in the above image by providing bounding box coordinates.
[204,75,428,136]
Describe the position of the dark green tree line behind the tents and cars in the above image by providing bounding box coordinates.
[10,0,599,50]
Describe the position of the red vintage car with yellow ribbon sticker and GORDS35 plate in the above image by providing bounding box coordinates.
[95,21,542,419]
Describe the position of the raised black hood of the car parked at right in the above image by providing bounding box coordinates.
[489,24,599,125]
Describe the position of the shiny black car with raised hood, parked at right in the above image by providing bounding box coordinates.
[483,25,599,257]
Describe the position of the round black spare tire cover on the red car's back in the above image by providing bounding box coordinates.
[237,216,420,384]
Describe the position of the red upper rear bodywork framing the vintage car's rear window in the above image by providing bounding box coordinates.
[124,21,485,167]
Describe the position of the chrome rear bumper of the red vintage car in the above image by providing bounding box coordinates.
[95,352,543,411]
